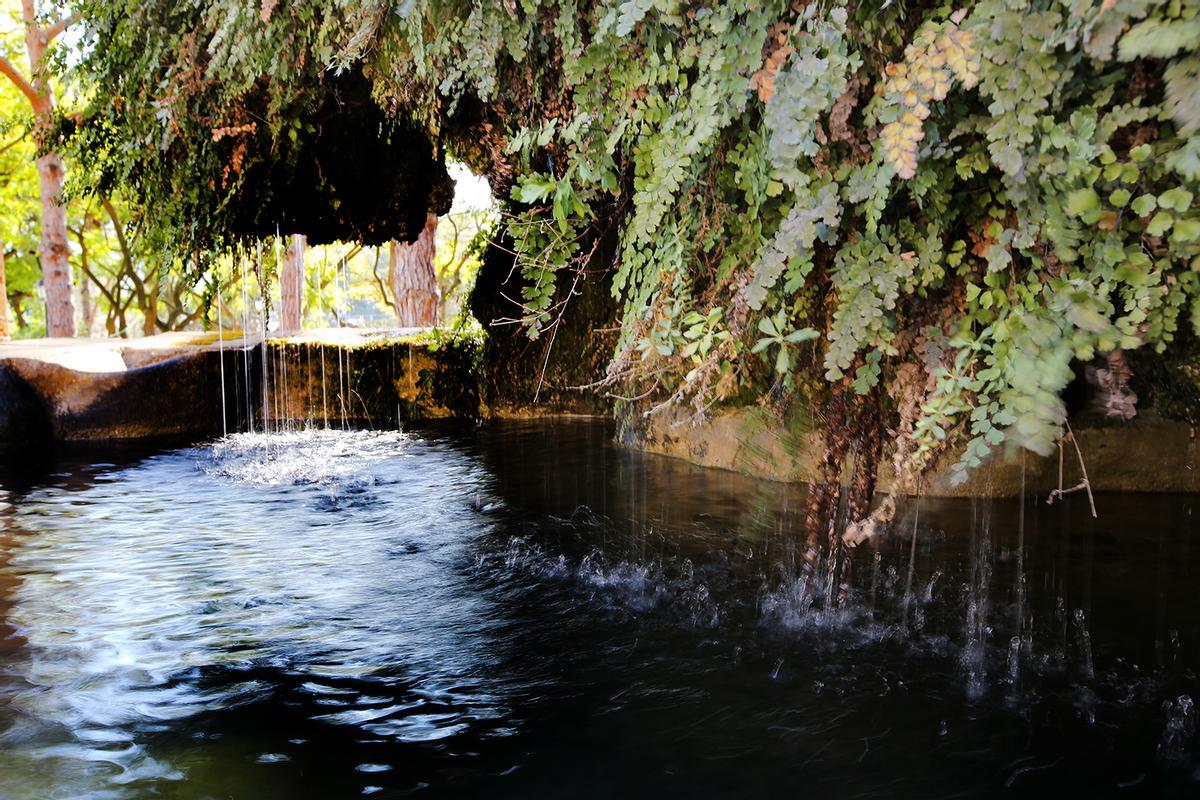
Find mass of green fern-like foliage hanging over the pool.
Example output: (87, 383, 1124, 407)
(65, 0, 1200, 491)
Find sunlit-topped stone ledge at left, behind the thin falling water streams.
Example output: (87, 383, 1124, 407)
(0, 332, 480, 449)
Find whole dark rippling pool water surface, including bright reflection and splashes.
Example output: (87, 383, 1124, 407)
(0, 421, 1200, 800)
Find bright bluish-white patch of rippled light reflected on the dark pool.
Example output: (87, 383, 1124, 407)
(0, 433, 520, 796)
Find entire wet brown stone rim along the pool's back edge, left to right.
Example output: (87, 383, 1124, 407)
(0, 326, 1196, 497)
